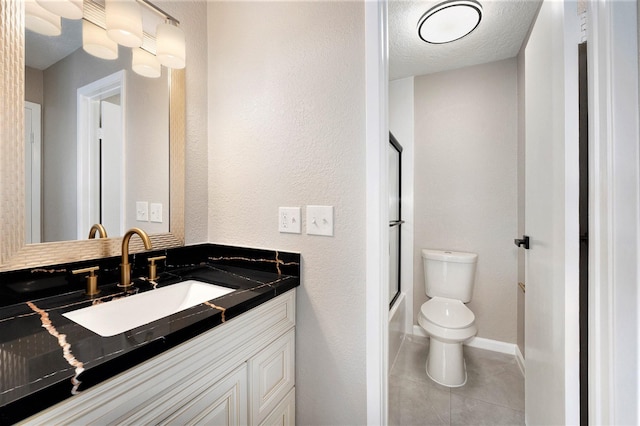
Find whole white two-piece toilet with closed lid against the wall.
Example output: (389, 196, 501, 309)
(418, 249, 478, 387)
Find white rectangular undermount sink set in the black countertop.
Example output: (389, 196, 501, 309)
(62, 280, 234, 337)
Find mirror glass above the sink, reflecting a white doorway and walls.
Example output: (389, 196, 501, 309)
(25, 18, 169, 244)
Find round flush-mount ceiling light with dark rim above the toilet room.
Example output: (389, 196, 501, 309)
(418, 0, 482, 44)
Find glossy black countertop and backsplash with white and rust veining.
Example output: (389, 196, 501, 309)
(0, 244, 300, 424)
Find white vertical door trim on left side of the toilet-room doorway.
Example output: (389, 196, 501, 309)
(364, 0, 389, 425)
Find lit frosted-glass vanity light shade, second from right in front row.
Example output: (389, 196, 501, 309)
(104, 0, 142, 47)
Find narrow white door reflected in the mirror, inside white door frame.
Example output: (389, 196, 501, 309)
(96, 101, 124, 236)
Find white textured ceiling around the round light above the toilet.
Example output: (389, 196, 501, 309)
(389, 0, 541, 80)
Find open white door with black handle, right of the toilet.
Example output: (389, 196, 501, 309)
(525, 0, 579, 426)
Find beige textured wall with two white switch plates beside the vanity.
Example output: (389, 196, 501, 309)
(208, 2, 366, 425)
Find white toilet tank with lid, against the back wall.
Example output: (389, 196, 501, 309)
(422, 249, 478, 303)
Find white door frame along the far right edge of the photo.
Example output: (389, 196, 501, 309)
(587, 0, 640, 424)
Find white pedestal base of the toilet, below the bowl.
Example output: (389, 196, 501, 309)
(426, 336, 467, 388)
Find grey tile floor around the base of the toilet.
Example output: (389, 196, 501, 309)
(389, 335, 524, 426)
